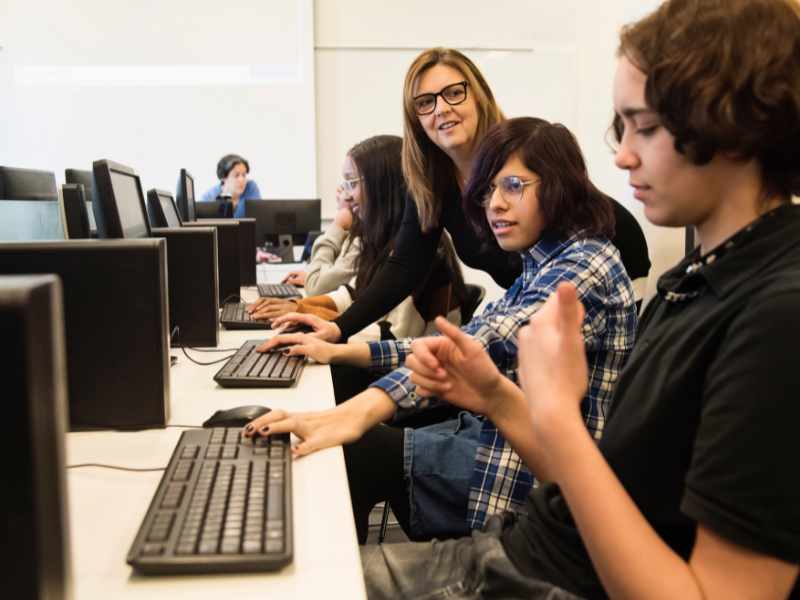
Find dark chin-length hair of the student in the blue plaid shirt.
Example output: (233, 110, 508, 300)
(464, 117, 614, 239)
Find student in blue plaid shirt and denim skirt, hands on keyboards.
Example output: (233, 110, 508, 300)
(245, 118, 636, 543)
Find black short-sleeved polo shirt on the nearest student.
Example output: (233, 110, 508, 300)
(503, 206, 800, 598)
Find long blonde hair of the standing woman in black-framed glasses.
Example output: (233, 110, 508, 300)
(403, 48, 504, 231)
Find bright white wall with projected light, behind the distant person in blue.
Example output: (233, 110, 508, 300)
(0, 0, 316, 197)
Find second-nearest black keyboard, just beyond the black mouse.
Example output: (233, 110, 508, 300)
(214, 340, 305, 387)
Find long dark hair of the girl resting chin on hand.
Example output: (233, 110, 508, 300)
(347, 135, 407, 292)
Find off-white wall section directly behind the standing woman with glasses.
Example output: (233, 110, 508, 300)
(315, 0, 683, 296)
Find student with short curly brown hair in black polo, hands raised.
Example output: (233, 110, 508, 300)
(364, 0, 800, 600)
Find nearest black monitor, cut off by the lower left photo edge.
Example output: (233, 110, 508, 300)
(0, 275, 72, 600)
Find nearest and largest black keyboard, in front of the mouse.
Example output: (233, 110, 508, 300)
(127, 428, 293, 574)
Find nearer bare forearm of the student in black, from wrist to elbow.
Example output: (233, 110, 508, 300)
(548, 418, 704, 600)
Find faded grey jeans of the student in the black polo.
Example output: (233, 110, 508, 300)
(361, 515, 579, 600)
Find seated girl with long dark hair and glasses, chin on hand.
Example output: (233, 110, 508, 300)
(249, 135, 465, 340)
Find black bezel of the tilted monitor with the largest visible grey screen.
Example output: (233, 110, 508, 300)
(92, 159, 151, 239)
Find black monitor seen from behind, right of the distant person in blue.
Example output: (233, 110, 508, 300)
(244, 198, 321, 246)
